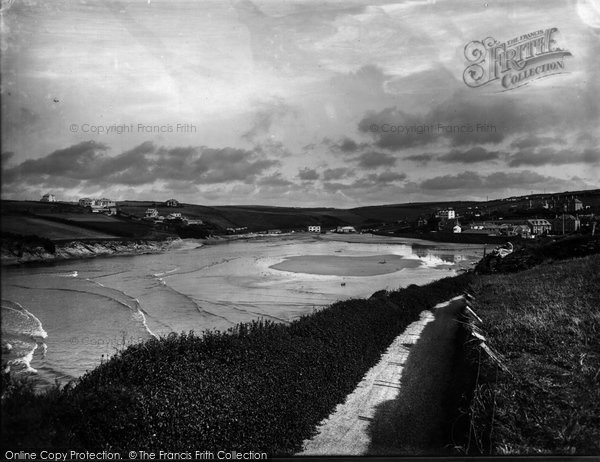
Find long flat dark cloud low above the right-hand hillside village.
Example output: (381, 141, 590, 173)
(420, 170, 572, 191)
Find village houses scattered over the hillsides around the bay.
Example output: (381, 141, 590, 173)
(35, 193, 600, 239)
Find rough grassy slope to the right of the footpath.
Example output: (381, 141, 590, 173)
(468, 255, 600, 455)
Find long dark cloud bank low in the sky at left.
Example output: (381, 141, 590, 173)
(3, 141, 279, 186)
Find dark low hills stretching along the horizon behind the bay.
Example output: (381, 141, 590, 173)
(0, 189, 600, 239)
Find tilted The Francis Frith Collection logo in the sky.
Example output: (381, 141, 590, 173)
(463, 27, 572, 91)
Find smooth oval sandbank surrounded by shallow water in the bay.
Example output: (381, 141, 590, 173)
(271, 254, 421, 277)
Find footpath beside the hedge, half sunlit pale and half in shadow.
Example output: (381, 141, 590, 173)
(298, 297, 464, 455)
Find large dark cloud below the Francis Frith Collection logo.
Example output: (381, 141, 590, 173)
(358, 92, 580, 151)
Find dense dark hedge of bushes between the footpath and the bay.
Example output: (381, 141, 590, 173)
(2, 274, 471, 455)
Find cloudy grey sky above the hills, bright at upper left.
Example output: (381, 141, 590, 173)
(1, 0, 600, 207)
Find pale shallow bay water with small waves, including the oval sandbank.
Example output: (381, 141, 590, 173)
(1, 236, 482, 387)
